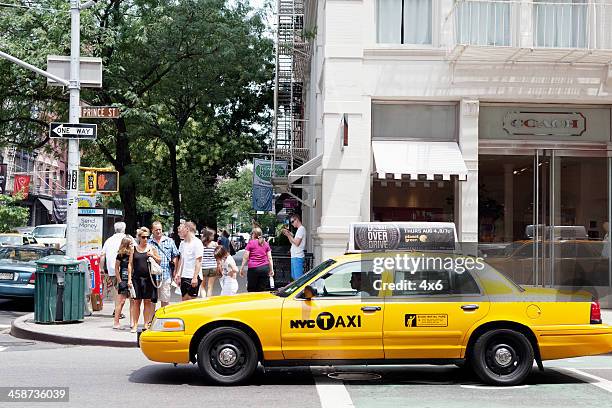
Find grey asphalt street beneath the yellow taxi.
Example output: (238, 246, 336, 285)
(0, 342, 612, 408)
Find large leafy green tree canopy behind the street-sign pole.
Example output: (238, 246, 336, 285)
(0, 0, 273, 236)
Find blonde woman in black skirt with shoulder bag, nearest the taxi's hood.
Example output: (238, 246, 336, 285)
(129, 227, 161, 333)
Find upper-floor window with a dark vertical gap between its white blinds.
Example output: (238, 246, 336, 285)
(376, 0, 433, 44)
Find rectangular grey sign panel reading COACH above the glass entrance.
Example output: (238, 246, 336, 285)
(479, 106, 610, 142)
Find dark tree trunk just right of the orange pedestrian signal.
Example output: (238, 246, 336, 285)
(115, 119, 137, 234)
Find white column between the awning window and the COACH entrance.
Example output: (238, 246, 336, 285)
(456, 99, 480, 242)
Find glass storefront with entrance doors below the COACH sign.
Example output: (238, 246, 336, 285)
(478, 150, 611, 290)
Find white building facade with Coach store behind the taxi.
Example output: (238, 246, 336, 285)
(289, 0, 612, 305)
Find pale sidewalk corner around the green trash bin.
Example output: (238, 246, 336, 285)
(11, 299, 612, 347)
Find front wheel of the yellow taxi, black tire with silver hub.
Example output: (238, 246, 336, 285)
(197, 327, 258, 385)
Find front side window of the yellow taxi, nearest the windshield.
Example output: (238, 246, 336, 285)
(310, 262, 380, 298)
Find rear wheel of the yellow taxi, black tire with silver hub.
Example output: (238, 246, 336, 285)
(470, 329, 533, 385)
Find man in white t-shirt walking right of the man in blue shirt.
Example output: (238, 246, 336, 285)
(174, 222, 204, 300)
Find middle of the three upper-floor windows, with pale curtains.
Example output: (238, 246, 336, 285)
(455, 0, 511, 46)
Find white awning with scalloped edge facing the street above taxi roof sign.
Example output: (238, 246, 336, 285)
(372, 140, 468, 180)
